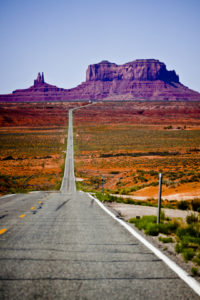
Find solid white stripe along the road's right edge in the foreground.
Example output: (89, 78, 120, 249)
(87, 193, 200, 296)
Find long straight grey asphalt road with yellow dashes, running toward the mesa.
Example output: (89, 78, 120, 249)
(0, 112, 199, 300)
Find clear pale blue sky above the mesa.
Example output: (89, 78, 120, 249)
(0, 0, 200, 94)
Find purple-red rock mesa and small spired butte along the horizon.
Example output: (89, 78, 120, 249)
(0, 59, 200, 102)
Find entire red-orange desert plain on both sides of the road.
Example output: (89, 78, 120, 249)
(0, 101, 200, 201)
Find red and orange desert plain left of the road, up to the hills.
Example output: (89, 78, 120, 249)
(0, 103, 78, 194)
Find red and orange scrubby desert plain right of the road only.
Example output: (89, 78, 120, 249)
(74, 102, 200, 200)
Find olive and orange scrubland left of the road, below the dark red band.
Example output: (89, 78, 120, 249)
(0, 127, 66, 194)
